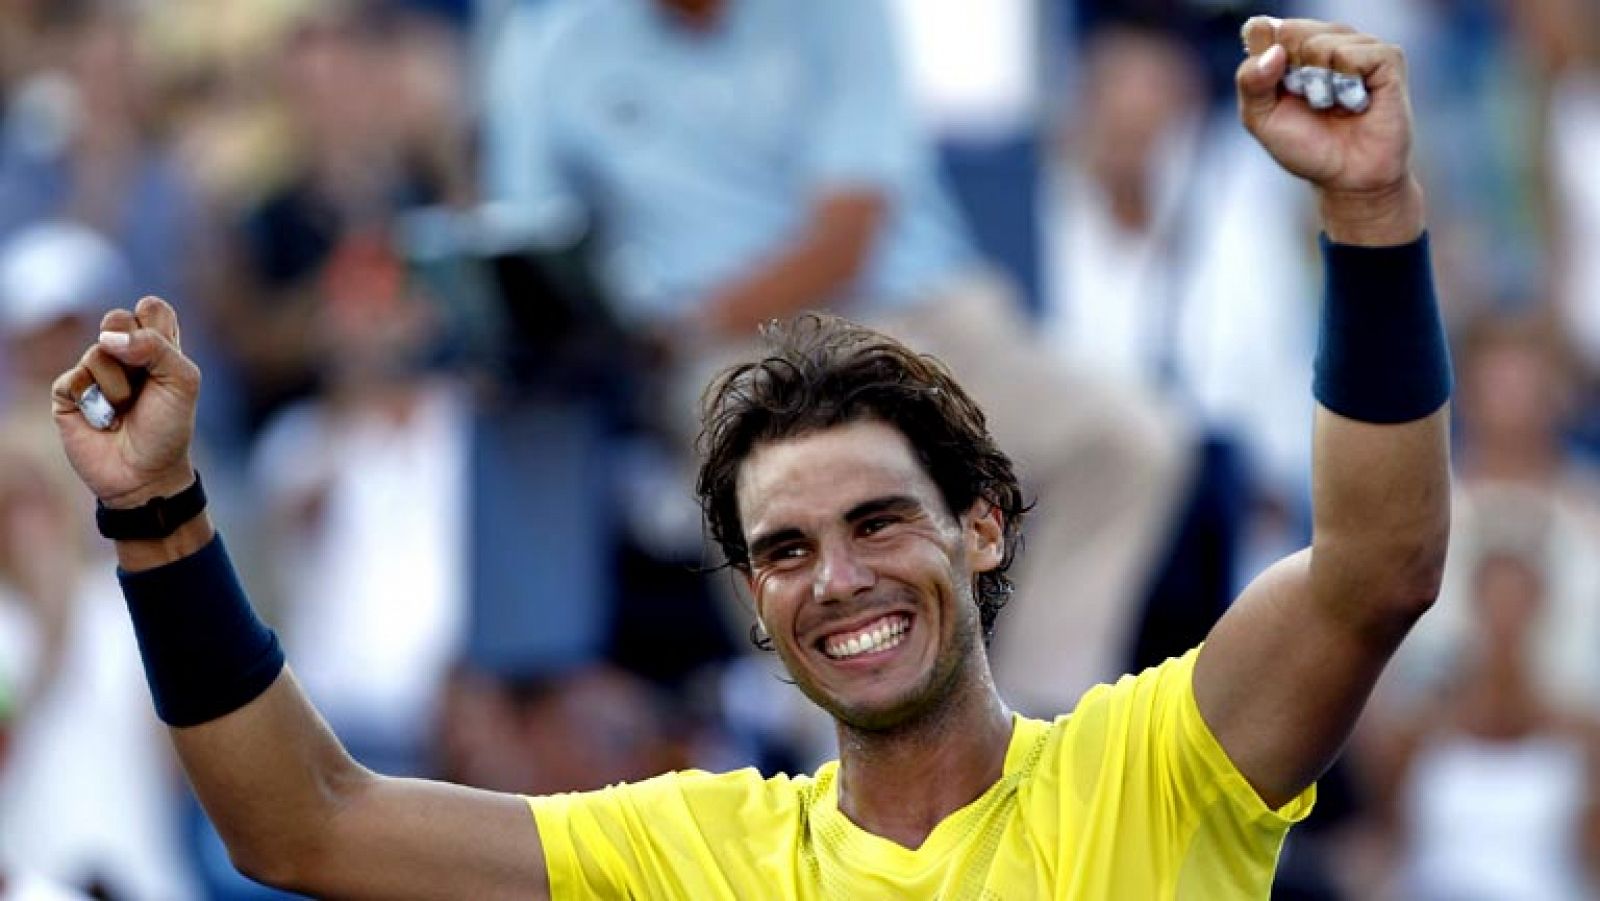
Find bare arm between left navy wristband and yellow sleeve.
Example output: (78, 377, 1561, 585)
(171, 656, 549, 899)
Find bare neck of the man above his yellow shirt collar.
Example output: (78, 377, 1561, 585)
(838, 674, 1011, 848)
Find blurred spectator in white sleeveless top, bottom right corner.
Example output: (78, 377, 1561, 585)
(1358, 552, 1600, 901)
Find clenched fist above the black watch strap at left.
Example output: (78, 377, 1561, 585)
(51, 298, 200, 507)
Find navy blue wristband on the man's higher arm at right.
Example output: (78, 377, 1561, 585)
(1314, 234, 1454, 424)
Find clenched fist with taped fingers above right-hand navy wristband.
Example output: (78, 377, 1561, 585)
(1235, 16, 1424, 245)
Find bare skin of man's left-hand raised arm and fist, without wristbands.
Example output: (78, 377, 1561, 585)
(51, 298, 549, 898)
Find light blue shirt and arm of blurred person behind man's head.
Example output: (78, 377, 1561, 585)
(486, 0, 979, 333)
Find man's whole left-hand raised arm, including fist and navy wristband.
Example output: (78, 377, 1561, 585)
(51, 298, 549, 898)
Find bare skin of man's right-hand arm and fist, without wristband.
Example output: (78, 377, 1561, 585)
(1194, 19, 1450, 807)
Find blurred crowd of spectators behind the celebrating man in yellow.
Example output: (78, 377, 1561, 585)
(0, 0, 1600, 901)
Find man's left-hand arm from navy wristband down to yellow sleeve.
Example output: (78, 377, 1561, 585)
(132, 544, 542, 898)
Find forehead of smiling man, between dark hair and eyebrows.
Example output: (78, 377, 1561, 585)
(738, 421, 938, 536)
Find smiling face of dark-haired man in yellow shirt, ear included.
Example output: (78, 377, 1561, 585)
(738, 421, 1003, 731)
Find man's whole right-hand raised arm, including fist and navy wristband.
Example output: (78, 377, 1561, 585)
(1194, 18, 1450, 805)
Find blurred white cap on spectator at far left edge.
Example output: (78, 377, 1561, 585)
(0, 221, 130, 334)
